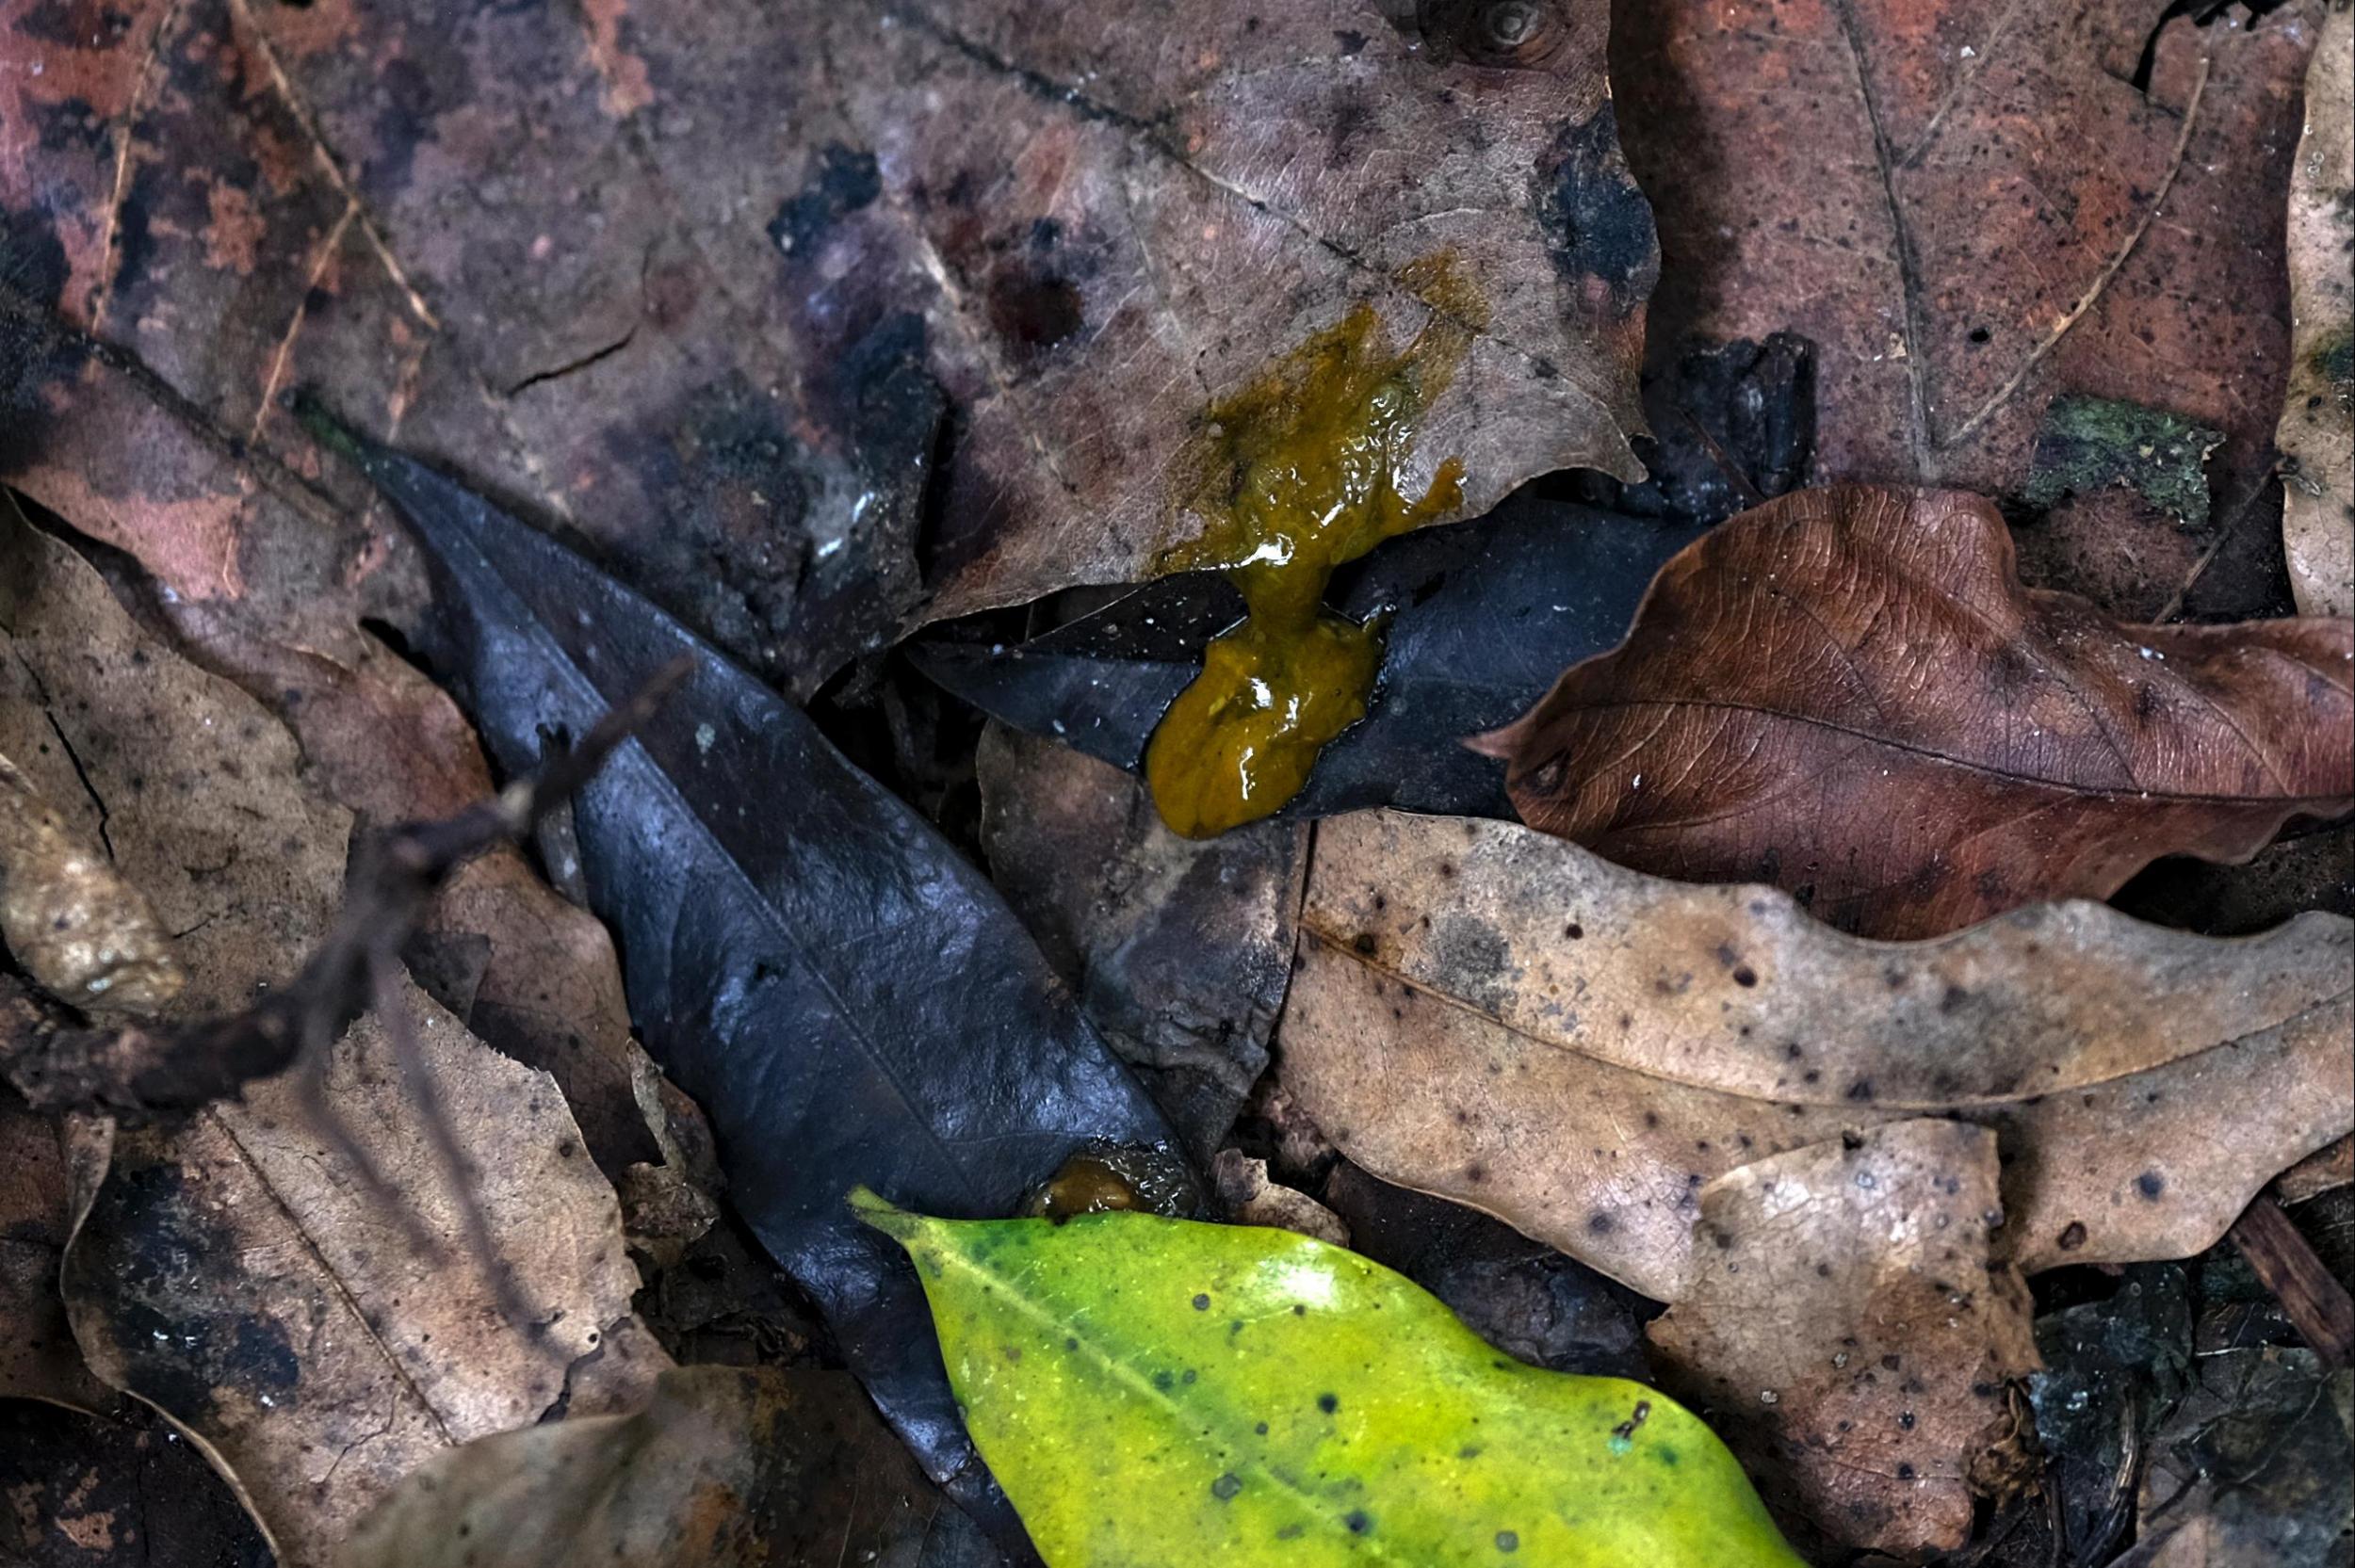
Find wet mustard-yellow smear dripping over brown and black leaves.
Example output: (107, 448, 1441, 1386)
(1145, 254, 1486, 838)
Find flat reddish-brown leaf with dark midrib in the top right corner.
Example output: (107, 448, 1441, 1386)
(1611, 0, 2320, 567)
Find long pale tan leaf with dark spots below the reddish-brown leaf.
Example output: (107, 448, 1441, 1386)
(1276, 813, 2355, 1302)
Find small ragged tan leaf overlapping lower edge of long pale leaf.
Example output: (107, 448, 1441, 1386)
(1648, 1121, 2038, 1554)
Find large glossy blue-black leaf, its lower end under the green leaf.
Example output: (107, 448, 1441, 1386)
(332, 421, 1168, 1524)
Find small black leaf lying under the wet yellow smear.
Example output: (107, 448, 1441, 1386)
(909, 493, 1700, 819)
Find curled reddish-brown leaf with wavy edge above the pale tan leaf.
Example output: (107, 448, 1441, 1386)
(1482, 485, 2355, 937)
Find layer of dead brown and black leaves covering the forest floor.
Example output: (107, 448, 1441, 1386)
(0, 0, 2355, 1568)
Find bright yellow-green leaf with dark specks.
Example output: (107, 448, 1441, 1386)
(851, 1189, 1804, 1568)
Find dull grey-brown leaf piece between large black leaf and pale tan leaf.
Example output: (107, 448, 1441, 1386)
(975, 725, 1309, 1166)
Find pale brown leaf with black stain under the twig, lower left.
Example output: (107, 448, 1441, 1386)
(64, 989, 662, 1568)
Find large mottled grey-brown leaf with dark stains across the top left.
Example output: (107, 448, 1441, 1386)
(0, 0, 1656, 692)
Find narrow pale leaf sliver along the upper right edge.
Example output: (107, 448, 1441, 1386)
(2275, 0, 2355, 615)
